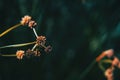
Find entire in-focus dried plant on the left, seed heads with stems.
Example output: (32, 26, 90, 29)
(0, 15, 52, 59)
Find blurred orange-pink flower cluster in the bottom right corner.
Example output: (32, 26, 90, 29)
(96, 49, 120, 80)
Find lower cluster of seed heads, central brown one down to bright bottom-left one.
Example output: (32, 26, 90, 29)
(16, 36, 52, 59)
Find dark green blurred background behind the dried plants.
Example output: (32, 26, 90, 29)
(0, 0, 120, 80)
